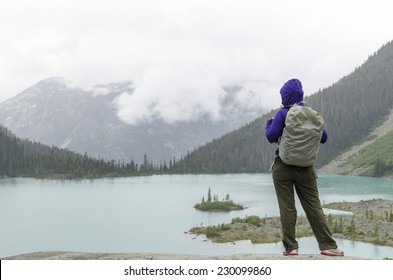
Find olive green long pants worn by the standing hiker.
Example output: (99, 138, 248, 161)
(272, 160, 337, 251)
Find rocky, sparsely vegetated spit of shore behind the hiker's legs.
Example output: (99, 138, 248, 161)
(189, 199, 393, 246)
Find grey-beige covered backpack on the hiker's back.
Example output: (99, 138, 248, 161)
(279, 104, 324, 167)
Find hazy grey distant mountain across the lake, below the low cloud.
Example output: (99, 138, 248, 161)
(0, 77, 261, 163)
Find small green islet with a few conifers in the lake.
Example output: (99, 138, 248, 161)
(194, 188, 244, 212)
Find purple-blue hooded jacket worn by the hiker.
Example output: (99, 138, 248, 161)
(265, 79, 328, 147)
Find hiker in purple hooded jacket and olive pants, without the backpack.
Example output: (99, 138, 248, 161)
(266, 79, 344, 256)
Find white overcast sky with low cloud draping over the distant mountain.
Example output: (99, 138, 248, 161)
(0, 0, 393, 123)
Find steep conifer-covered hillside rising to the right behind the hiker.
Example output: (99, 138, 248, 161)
(171, 42, 393, 173)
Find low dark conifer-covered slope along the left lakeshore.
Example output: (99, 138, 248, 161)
(0, 126, 158, 179)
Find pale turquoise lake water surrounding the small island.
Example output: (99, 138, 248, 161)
(0, 174, 393, 259)
